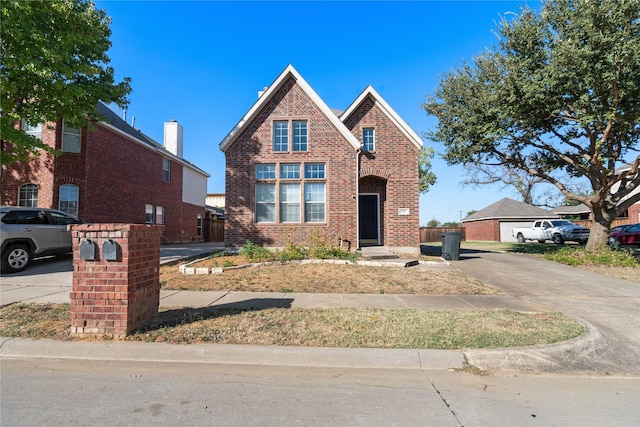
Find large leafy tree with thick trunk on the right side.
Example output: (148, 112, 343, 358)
(423, 0, 640, 248)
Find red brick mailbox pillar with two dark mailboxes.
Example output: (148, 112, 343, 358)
(71, 224, 164, 337)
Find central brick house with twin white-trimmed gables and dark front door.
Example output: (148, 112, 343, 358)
(220, 65, 422, 251)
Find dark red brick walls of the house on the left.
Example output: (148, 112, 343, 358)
(1, 122, 205, 242)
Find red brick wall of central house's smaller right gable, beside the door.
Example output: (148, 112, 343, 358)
(345, 98, 420, 247)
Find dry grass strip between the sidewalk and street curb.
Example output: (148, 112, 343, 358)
(0, 304, 583, 349)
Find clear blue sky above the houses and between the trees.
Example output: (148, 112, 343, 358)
(96, 0, 540, 225)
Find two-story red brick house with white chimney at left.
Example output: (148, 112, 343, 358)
(0, 104, 209, 242)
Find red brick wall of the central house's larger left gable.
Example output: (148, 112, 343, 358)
(225, 79, 356, 247)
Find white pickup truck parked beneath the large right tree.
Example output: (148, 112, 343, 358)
(511, 219, 589, 245)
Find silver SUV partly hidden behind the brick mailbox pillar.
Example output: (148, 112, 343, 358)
(0, 206, 81, 273)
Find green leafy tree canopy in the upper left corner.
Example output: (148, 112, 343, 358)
(0, 0, 131, 164)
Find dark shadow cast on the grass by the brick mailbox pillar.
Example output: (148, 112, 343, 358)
(135, 298, 293, 333)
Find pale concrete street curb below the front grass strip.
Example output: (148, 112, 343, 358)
(0, 337, 464, 370)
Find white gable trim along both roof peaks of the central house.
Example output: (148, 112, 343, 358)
(220, 64, 422, 151)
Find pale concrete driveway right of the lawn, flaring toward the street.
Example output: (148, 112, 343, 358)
(452, 251, 640, 375)
